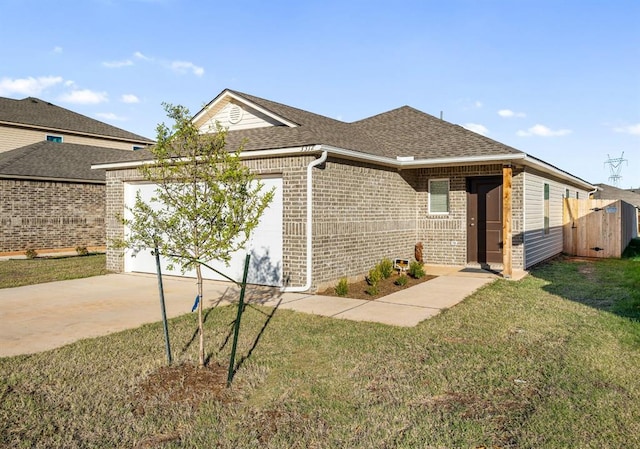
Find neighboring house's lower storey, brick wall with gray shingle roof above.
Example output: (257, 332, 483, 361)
(0, 141, 138, 253)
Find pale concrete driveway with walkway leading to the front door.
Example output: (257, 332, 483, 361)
(0, 266, 524, 357)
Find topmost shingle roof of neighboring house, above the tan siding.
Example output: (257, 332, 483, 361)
(0, 97, 153, 143)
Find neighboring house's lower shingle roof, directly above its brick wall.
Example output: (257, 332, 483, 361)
(0, 141, 133, 181)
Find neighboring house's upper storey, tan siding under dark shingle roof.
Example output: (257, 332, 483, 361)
(0, 97, 153, 153)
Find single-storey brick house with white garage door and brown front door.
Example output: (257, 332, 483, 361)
(95, 90, 594, 291)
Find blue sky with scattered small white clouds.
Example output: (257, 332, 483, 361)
(0, 0, 640, 188)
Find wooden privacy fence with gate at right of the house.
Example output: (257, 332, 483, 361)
(563, 198, 638, 258)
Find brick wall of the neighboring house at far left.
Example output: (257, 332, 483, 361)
(0, 179, 106, 252)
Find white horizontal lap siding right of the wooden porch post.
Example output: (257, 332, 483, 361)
(524, 172, 588, 269)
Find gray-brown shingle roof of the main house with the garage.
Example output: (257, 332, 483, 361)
(101, 90, 524, 162)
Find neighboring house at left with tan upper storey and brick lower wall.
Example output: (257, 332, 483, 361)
(0, 97, 153, 255)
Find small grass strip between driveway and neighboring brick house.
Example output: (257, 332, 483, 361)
(0, 254, 108, 288)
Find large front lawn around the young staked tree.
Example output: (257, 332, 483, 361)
(0, 260, 640, 449)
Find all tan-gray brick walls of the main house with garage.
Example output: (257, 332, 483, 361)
(106, 156, 523, 290)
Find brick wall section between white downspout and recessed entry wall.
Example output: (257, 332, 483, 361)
(312, 159, 417, 287)
